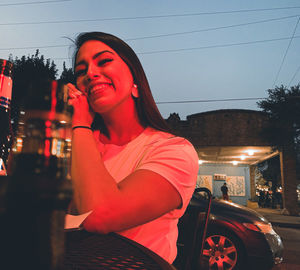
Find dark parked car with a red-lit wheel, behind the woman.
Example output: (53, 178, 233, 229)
(174, 192, 283, 270)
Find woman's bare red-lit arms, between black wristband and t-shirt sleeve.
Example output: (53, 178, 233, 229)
(72, 128, 181, 233)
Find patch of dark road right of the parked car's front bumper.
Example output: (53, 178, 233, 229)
(272, 226, 300, 270)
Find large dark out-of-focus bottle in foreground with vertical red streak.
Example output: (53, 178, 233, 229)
(0, 80, 72, 270)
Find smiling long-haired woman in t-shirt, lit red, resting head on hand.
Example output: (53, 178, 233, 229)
(68, 32, 198, 263)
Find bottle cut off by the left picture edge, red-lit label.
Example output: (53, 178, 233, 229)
(0, 59, 13, 175)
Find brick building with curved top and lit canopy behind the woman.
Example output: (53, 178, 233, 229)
(167, 109, 297, 214)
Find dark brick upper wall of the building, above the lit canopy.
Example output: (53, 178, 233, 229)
(167, 110, 270, 148)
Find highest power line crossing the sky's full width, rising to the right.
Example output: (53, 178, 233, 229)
(0, 6, 300, 26)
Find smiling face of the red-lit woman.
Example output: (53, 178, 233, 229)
(75, 40, 134, 114)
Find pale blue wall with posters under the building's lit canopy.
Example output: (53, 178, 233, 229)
(198, 164, 250, 206)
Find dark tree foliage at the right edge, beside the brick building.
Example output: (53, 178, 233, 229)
(257, 85, 300, 178)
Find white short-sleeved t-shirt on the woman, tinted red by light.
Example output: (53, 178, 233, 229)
(94, 128, 198, 263)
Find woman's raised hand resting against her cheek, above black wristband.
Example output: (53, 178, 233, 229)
(67, 83, 95, 126)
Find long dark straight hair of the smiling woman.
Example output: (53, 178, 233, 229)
(73, 32, 170, 136)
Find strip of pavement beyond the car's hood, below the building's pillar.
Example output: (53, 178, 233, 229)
(251, 207, 300, 229)
